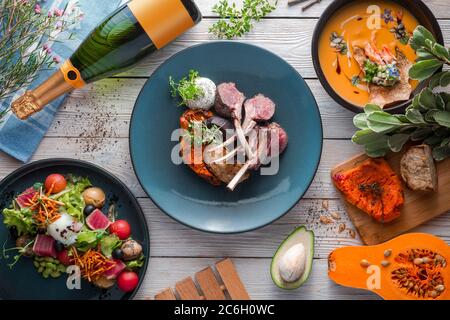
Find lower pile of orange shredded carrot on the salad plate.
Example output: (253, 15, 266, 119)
(72, 248, 114, 282)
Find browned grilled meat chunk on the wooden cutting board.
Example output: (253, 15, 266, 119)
(400, 145, 438, 191)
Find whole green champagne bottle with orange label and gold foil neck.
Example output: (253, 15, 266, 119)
(11, 0, 202, 120)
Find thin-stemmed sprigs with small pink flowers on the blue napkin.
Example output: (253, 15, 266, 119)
(0, 0, 83, 121)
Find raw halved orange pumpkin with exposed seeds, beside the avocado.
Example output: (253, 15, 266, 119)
(328, 233, 450, 300)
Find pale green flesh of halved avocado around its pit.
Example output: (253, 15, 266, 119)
(270, 226, 314, 290)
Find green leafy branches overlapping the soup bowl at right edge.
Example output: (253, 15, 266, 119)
(352, 26, 450, 161)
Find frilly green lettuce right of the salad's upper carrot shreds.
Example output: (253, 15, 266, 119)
(55, 177, 92, 221)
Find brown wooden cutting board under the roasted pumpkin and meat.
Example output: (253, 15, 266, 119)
(331, 153, 450, 245)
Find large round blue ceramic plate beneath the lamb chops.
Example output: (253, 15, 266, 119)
(130, 41, 322, 233)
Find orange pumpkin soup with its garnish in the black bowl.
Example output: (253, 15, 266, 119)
(319, 1, 419, 108)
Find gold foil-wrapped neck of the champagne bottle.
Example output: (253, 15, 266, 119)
(11, 60, 84, 120)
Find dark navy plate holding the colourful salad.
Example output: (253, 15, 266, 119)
(0, 159, 150, 300)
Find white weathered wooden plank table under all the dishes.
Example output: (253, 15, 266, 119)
(0, 0, 450, 299)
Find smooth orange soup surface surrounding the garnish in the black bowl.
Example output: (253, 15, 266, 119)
(319, 1, 419, 107)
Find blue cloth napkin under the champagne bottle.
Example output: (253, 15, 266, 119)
(0, 0, 122, 162)
